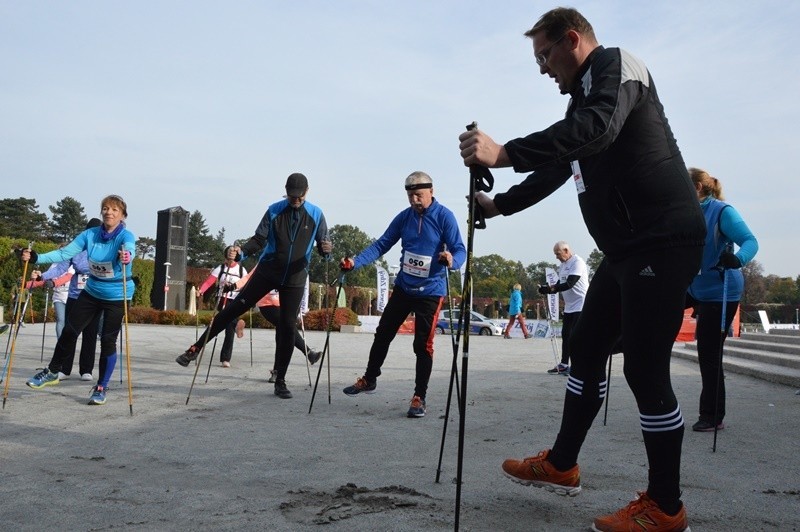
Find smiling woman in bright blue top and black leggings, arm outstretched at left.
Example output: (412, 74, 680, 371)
(22, 195, 136, 405)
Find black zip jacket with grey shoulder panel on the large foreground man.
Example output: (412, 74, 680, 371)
(494, 46, 706, 258)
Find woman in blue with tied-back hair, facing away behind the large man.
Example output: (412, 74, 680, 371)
(686, 168, 758, 432)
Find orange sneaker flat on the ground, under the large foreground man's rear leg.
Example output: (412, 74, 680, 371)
(592, 492, 691, 532)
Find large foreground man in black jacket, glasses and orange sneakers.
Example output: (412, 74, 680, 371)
(459, 8, 705, 530)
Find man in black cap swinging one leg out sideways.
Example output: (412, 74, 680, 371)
(175, 174, 332, 399)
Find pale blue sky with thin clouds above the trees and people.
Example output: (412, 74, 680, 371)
(0, 0, 800, 277)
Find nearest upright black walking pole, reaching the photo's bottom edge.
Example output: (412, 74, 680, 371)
(455, 122, 494, 530)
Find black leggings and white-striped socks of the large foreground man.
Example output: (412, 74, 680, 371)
(551, 246, 702, 507)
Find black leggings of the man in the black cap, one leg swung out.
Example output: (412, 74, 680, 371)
(194, 264, 305, 380)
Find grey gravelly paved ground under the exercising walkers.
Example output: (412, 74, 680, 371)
(0, 325, 800, 532)
